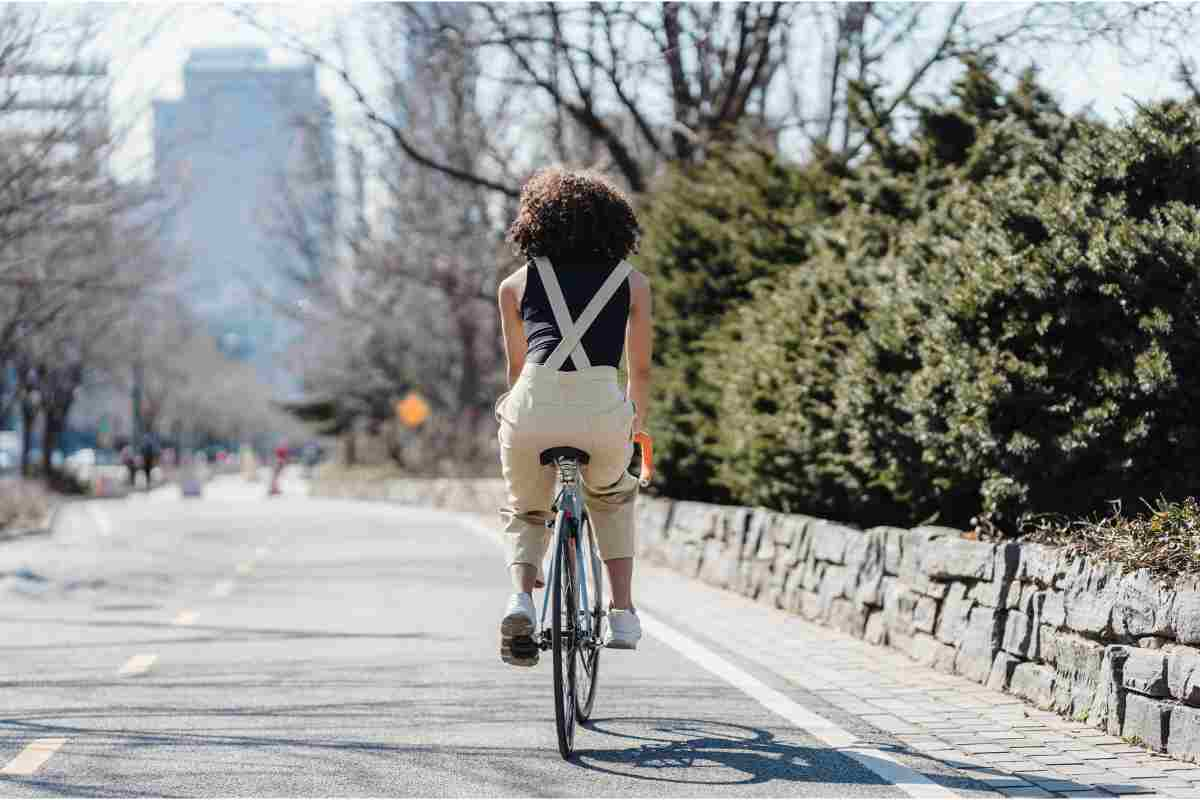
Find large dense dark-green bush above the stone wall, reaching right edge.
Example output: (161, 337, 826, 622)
(647, 59, 1200, 529)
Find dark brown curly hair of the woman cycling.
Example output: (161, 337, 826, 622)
(508, 167, 641, 264)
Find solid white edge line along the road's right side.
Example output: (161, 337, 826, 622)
(456, 515, 959, 798)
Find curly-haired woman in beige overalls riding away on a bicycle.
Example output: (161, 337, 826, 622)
(496, 167, 652, 667)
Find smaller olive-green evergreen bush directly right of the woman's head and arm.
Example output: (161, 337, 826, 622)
(637, 151, 833, 500)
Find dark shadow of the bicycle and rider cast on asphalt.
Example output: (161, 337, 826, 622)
(575, 717, 890, 787)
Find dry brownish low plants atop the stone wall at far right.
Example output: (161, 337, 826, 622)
(1022, 498, 1200, 577)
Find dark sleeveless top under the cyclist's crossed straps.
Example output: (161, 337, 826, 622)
(521, 261, 629, 372)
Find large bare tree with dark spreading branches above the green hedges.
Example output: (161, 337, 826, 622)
(238, 2, 1195, 198)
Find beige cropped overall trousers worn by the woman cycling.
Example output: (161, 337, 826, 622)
(496, 363, 637, 566)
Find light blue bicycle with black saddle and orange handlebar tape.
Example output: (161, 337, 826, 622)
(534, 433, 654, 759)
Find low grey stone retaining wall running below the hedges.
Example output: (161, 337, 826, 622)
(316, 480, 1200, 760)
